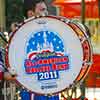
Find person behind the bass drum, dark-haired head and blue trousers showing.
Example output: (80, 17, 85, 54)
(21, 0, 59, 100)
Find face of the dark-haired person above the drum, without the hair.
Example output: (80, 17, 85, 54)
(35, 2, 48, 16)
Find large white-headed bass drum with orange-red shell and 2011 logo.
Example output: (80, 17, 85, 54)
(6, 16, 92, 95)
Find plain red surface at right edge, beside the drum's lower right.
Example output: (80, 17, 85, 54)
(85, 54, 100, 88)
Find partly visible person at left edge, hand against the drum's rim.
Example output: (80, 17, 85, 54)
(0, 26, 15, 100)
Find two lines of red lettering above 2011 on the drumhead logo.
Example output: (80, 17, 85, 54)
(25, 56, 69, 73)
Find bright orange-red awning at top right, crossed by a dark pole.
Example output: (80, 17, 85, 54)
(53, 0, 99, 18)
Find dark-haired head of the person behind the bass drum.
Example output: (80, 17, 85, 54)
(24, 0, 48, 18)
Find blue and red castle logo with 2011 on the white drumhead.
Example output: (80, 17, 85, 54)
(24, 31, 69, 89)
